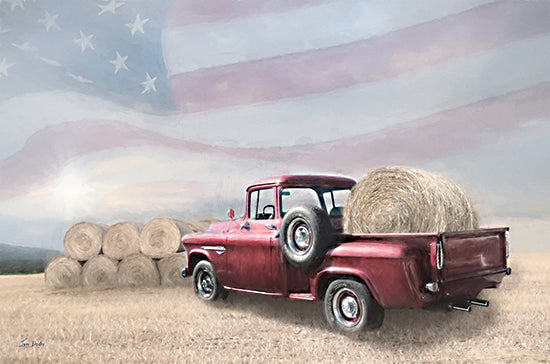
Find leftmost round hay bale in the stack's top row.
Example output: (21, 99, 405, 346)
(63, 222, 106, 261)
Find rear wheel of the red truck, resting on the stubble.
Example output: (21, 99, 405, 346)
(325, 279, 384, 333)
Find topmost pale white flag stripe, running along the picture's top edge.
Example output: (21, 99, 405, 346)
(162, 0, 491, 76)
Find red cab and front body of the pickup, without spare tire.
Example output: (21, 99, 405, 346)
(182, 176, 355, 295)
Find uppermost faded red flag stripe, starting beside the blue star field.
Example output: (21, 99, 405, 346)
(169, 1, 550, 113)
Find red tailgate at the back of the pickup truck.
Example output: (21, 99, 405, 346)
(440, 228, 509, 282)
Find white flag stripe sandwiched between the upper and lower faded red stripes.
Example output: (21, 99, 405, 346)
(173, 35, 550, 147)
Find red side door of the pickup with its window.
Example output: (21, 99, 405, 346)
(226, 187, 278, 292)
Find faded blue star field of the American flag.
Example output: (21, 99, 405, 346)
(0, 0, 172, 112)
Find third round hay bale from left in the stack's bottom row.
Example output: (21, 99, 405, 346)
(117, 253, 160, 287)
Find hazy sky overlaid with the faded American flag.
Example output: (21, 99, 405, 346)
(0, 0, 550, 253)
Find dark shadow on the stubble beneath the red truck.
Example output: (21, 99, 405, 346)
(215, 292, 499, 347)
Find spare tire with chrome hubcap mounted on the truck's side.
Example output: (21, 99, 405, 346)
(280, 205, 335, 268)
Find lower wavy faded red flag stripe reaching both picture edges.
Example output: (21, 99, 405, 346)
(0, 82, 550, 201)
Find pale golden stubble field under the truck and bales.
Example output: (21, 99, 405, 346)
(0, 254, 550, 363)
